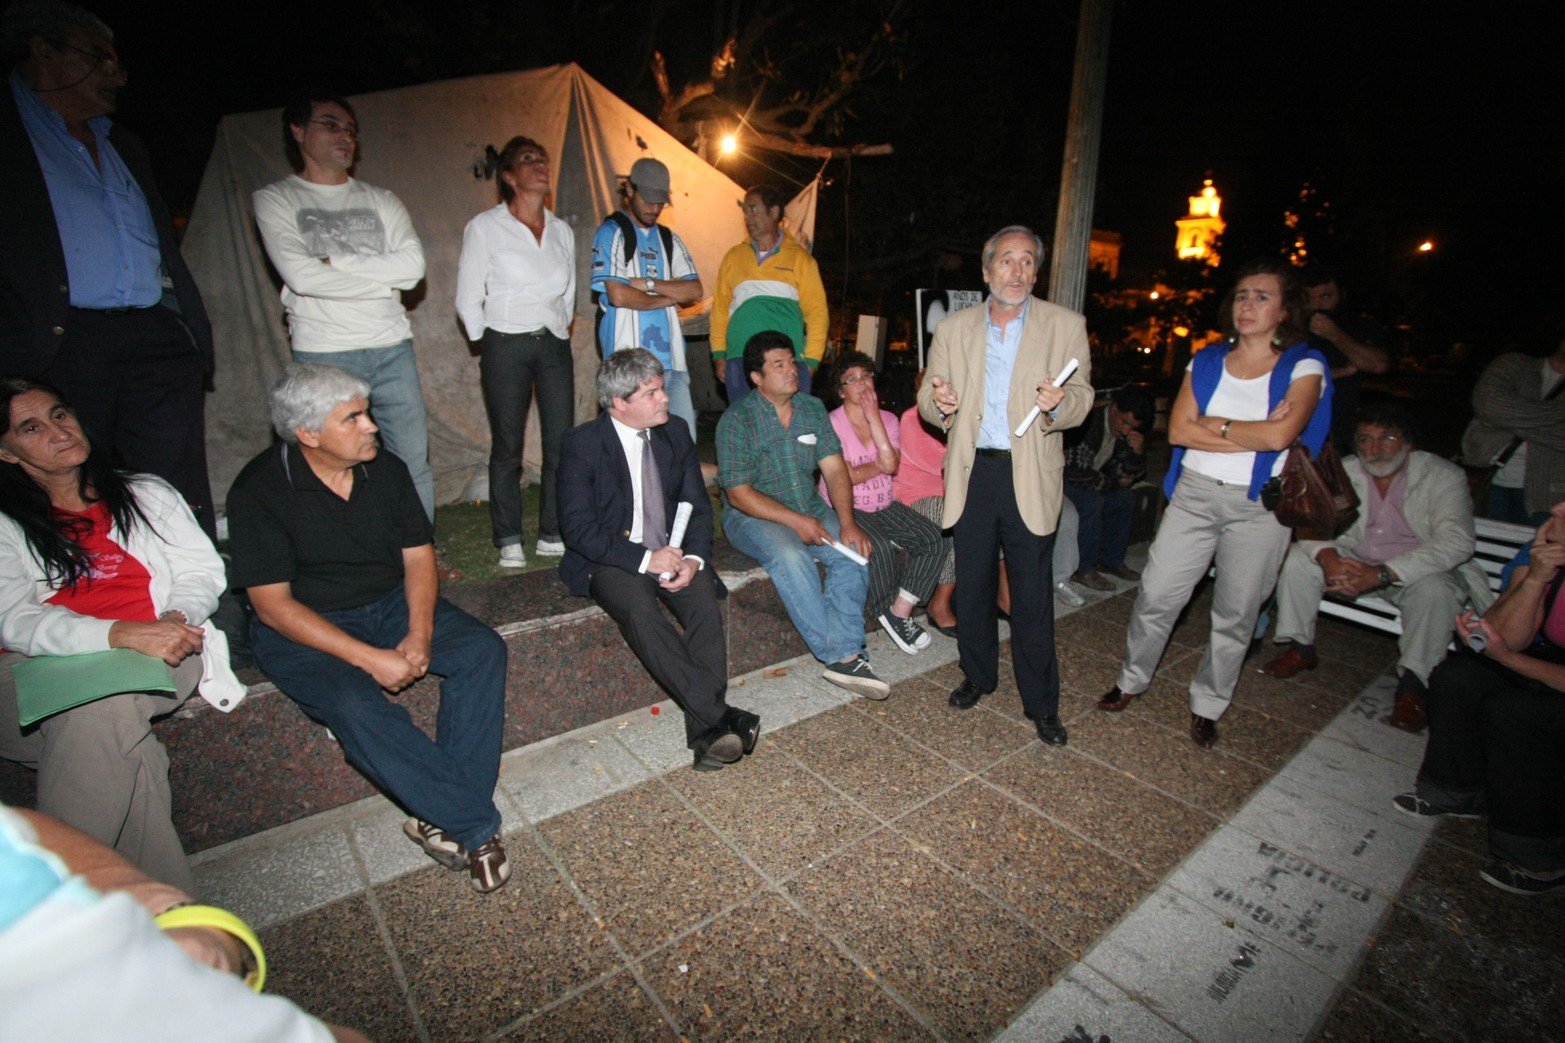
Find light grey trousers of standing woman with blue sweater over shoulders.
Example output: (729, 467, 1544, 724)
(1119, 470, 1293, 720)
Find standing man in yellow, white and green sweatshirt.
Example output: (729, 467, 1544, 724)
(712, 185, 829, 406)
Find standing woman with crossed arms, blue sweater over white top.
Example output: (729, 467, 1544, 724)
(1097, 260, 1332, 747)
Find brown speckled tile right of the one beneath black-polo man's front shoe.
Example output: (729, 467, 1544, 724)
(540, 771, 761, 954)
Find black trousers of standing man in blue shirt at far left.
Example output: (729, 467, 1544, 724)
(38, 307, 218, 537)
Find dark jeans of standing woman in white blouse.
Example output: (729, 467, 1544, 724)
(479, 329, 576, 547)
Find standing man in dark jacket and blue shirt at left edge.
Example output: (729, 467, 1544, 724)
(0, 0, 216, 536)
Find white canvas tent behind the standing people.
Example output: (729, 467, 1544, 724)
(183, 64, 814, 504)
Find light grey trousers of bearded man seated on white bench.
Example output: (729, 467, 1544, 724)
(1277, 547, 1468, 684)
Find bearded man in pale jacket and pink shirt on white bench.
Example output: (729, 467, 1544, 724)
(1261, 398, 1493, 731)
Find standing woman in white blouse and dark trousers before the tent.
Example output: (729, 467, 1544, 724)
(457, 136, 576, 568)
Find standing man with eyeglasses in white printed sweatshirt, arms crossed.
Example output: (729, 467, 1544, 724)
(254, 94, 454, 578)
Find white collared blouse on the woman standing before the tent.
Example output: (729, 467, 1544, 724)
(457, 204, 576, 340)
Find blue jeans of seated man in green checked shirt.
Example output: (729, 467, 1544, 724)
(723, 511, 870, 662)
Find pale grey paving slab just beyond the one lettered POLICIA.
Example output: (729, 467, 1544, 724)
(1232, 775, 1429, 897)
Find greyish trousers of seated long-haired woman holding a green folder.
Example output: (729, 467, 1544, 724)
(0, 651, 200, 894)
